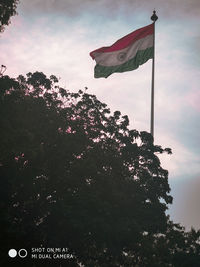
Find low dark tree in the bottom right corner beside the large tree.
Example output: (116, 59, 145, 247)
(126, 218, 200, 267)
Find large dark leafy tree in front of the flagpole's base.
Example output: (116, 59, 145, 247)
(0, 72, 180, 267)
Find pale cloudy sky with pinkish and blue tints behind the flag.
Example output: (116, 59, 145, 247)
(0, 0, 200, 230)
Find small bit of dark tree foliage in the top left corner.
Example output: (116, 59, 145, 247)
(0, 0, 19, 32)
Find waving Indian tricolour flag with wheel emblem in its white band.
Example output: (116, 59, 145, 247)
(90, 23, 154, 78)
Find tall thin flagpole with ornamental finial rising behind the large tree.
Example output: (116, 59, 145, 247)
(150, 10, 158, 136)
